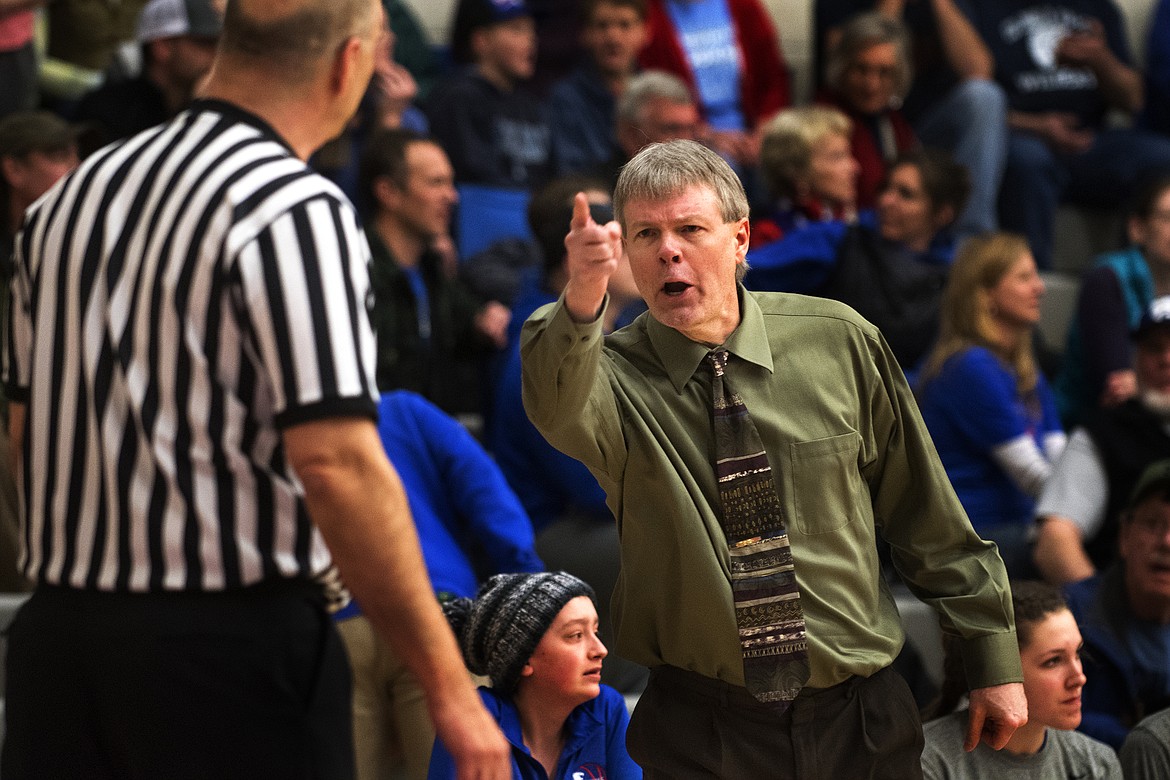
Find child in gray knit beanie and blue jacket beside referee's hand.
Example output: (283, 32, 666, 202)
(428, 572, 642, 780)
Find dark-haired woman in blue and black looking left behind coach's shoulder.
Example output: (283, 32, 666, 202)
(744, 149, 968, 368)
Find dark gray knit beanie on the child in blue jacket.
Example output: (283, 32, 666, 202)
(443, 572, 597, 695)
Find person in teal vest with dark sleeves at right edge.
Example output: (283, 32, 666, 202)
(1057, 175, 1170, 426)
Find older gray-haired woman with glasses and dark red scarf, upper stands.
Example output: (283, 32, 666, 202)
(821, 12, 917, 208)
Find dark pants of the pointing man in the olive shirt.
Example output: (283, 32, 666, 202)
(626, 667, 922, 780)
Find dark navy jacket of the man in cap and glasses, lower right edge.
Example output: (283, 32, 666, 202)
(1065, 562, 1170, 750)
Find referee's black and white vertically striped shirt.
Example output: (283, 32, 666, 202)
(5, 101, 377, 592)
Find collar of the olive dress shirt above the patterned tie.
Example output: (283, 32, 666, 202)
(646, 284, 773, 393)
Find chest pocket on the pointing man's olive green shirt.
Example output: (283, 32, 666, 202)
(789, 432, 863, 536)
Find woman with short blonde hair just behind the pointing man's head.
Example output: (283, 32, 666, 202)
(751, 105, 859, 247)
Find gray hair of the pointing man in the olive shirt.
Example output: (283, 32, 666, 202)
(613, 140, 748, 227)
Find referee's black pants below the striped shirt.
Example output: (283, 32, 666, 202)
(0, 582, 353, 780)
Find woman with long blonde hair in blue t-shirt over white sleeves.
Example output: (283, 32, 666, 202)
(918, 233, 1065, 577)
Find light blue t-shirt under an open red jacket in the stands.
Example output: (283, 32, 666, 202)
(666, 0, 748, 130)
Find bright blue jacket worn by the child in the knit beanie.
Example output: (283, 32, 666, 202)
(427, 685, 642, 780)
